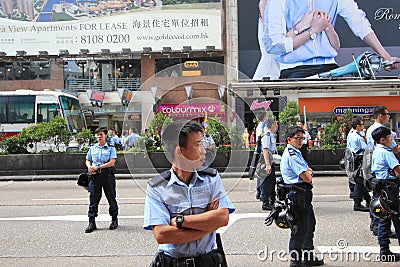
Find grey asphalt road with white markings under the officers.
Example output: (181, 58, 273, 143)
(0, 176, 400, 267)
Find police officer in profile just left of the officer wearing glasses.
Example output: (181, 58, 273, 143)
(260, 118, 278, 210)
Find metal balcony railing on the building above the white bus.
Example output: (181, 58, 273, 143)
(65, 78, 141, 92)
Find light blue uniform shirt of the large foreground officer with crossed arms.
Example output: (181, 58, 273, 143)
(143, 169, 235, 258)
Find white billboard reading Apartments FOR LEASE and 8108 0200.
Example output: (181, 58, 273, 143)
(0, 0, 222, 56)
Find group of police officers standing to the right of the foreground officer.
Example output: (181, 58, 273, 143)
(255, 106, 400, 266)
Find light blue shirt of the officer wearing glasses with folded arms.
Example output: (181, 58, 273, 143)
(280, 144, 308, 184)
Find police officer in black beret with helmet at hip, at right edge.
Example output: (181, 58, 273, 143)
(371, 127, 400, 261)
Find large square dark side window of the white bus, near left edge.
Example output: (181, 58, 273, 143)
(7, 95, 35, 123)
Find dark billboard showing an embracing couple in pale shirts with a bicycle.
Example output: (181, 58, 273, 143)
(238, 0, 400, 80)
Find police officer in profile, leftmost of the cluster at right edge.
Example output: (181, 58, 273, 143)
(347, 116, 371, 212)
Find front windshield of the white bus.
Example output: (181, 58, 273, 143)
(60, 96, 85, 133)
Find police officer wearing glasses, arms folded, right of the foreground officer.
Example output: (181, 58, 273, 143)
(280, 126, 324, 267)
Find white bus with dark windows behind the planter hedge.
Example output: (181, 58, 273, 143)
(0, 89, 86, 137)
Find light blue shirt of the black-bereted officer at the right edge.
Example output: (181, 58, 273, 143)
(371, 144, 400, 180)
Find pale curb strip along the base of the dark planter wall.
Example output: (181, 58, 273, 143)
(0, 170, 346, 181)
